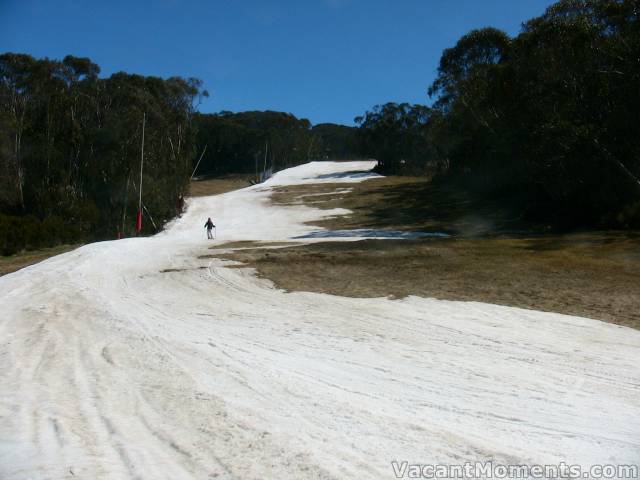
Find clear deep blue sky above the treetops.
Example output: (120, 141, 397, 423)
(0, 0, 553, 124)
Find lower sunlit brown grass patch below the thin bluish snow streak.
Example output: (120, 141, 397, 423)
(222, 233, 640, 328)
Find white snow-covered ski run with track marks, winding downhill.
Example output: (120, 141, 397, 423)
(0, 162, 640, 480)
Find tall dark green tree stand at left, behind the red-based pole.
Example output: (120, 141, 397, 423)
(0, 53, 206, 251)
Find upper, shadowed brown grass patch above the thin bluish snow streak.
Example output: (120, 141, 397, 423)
(271, 176, 548, 237)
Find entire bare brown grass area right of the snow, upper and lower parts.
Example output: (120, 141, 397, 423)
(220, 177, 640, 328)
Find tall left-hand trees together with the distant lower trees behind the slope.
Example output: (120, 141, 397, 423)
(0, 53, 356, 255)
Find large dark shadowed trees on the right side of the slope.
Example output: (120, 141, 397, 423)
(356, 0, 640, 228)
